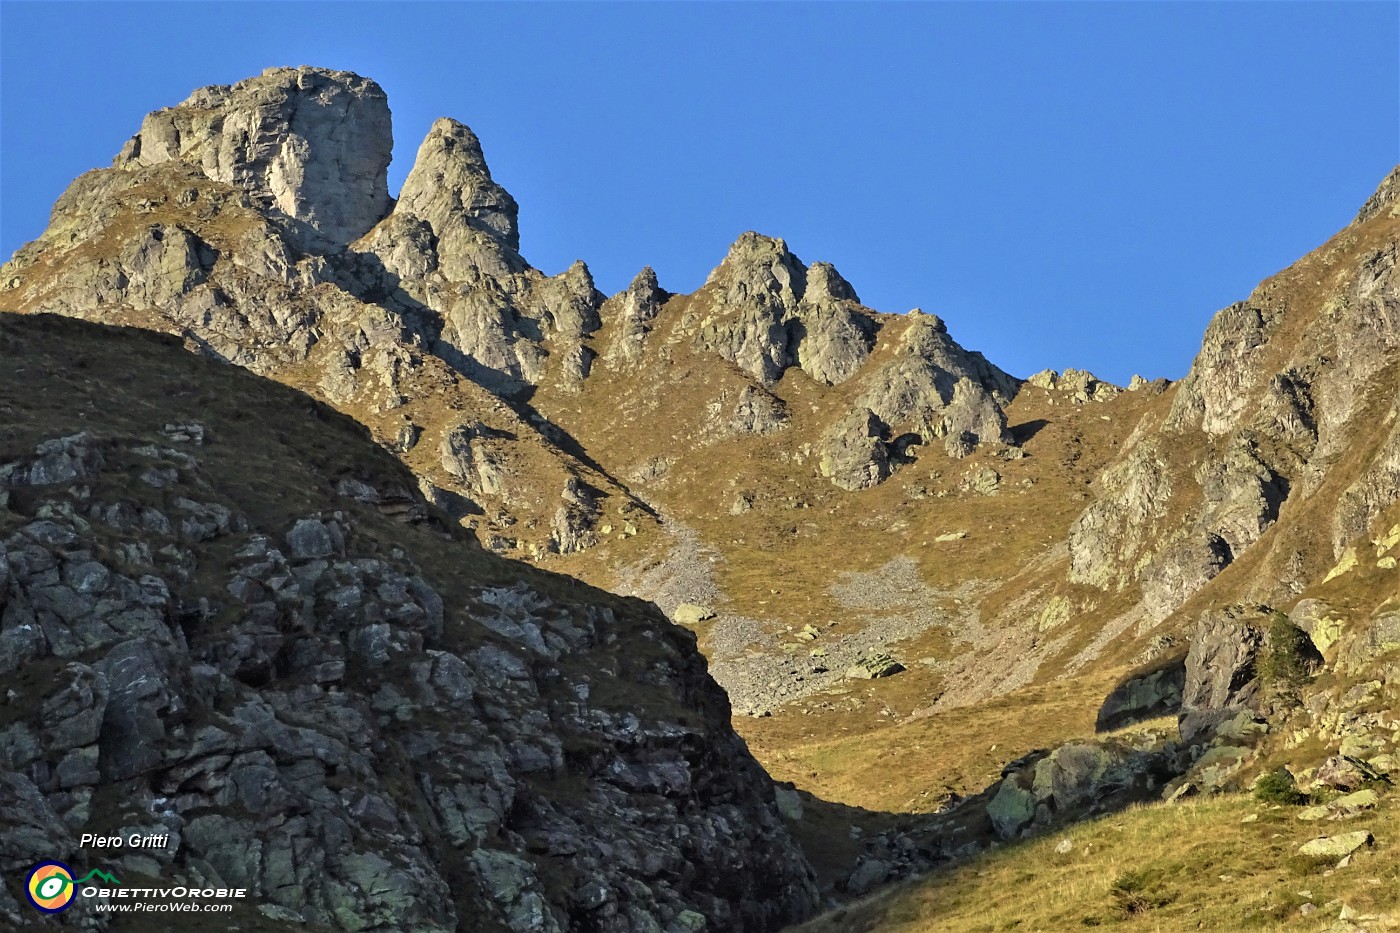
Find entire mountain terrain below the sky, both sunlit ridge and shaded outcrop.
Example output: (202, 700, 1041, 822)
(8, 67, 1400, 933)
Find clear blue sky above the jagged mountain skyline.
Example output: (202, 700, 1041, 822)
(0, 0, 1400, 381)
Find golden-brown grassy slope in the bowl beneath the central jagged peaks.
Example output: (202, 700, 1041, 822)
(536, 297, 1162, 745)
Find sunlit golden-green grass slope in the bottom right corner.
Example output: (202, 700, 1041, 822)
(792, 794, 1400, 933)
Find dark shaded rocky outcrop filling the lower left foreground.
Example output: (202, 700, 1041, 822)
(0, 315, 816, 933)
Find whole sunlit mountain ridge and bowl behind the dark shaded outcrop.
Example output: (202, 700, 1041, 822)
(8, 69, 1400, 929)
